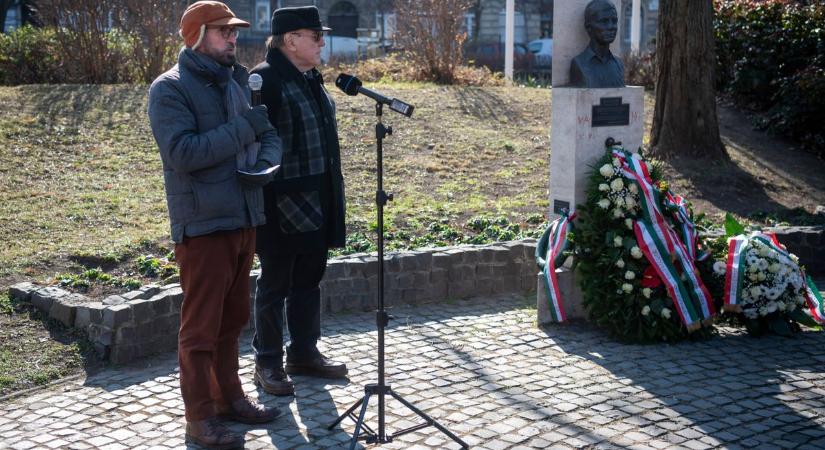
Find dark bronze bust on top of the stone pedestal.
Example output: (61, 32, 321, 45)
(570, 0, 625, 88)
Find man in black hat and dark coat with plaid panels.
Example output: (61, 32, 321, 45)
(246, 6, 347, 395)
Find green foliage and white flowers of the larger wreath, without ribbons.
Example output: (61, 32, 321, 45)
(575, 150, 724, 343)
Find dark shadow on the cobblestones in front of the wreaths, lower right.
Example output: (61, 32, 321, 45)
(543, 324, 825, 448)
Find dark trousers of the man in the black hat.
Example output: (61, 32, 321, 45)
(252, 249, 327, 368)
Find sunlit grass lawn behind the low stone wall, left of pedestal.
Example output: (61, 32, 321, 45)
(0, 85, 550, 284)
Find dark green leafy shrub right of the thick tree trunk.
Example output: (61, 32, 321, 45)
(714, 0, 825, 155)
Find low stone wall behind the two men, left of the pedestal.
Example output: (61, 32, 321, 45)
(9, 239, 536, 363)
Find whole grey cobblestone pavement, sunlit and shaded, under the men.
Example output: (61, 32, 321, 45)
(0, 298, 825, 450)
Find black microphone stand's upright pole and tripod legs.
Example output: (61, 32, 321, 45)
(327, 102, 470, 450)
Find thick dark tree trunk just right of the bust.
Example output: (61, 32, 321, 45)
(650, 0, 727, 159)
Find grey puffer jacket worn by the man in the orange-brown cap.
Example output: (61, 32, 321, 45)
(149, 49, 281, 243)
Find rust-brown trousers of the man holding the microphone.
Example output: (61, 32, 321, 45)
(175, 228, 255, 422)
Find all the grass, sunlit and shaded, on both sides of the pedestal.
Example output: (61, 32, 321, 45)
(0, 84, 825, 396)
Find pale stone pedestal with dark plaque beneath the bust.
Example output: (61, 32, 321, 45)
(537, 86, 644, 324)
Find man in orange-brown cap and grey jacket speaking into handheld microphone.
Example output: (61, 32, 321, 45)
(149, 1, 282, 449)
